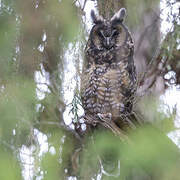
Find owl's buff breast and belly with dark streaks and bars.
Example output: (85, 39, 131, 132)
(81, 62, 135, 118)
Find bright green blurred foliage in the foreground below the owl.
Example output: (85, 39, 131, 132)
(82, 126, 180, 180)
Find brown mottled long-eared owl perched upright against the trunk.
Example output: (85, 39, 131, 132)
(81, 8, 137, 129)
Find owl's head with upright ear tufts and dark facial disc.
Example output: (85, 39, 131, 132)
(90, 8, 128, 50)
